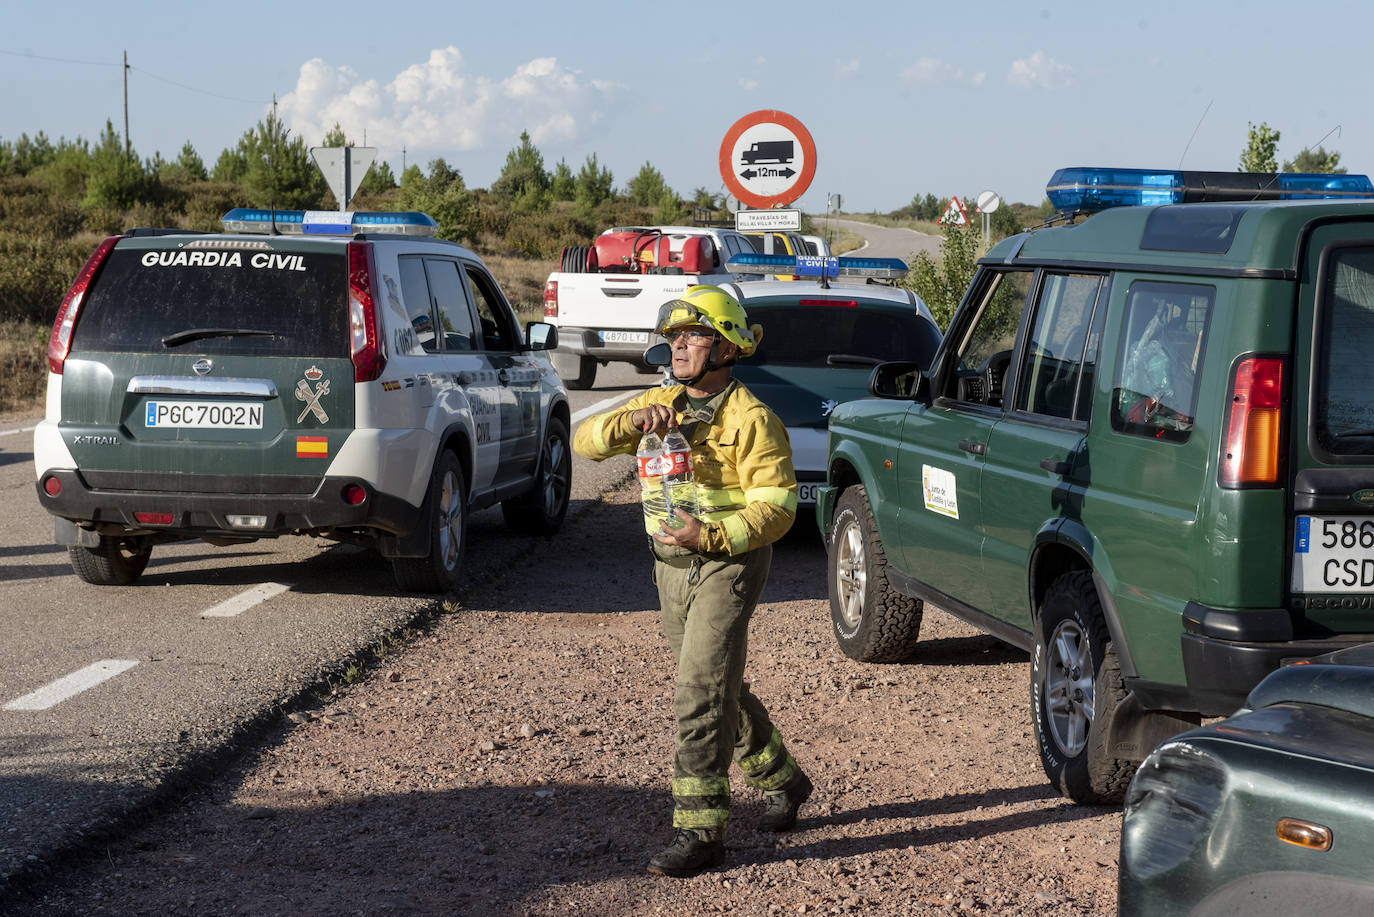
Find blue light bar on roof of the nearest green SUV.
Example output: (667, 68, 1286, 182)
(1044, 166, 1374, 213)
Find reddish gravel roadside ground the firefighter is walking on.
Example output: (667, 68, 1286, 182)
(10, 491, 1121, 917)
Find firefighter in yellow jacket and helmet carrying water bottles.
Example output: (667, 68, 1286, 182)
(573, 286, 812, 877)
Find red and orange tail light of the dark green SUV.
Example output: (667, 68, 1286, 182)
(1220, 356, 1283, 487)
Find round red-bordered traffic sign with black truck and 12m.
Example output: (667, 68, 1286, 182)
(720, 109, 816, 208)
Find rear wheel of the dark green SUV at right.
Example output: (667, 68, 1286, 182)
(1031, 571, 1132, 806)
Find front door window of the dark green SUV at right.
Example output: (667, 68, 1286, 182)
(938, 271, 1033, 406)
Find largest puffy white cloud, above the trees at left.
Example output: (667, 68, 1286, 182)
(279, 47, 616, 151)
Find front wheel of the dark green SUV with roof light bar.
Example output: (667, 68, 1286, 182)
(826, 485, 925, 663)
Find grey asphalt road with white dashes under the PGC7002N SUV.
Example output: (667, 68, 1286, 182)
(0, 364, 653, 890)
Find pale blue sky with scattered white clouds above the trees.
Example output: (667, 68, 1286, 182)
(0, 0, 1374, 212)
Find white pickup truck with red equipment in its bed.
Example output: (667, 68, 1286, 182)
(544, 225, 754, 389)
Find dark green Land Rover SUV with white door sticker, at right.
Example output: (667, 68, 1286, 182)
(818, 169, 1374, 803)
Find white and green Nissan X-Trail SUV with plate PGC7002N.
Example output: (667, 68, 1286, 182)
(33, 209, 572, 593)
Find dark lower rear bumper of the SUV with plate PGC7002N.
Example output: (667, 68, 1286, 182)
(36, 469, 419, 538)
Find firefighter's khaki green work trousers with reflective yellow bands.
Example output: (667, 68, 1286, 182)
(653, 542, 798, 836)
